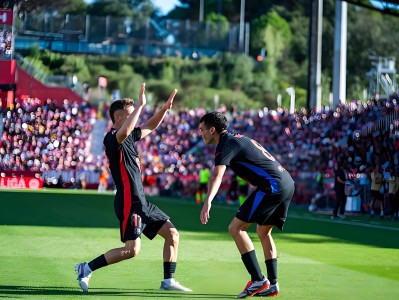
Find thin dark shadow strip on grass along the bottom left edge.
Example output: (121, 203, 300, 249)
(0, 285, 236, 299)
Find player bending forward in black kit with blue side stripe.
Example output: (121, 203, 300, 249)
(199, 112, 295, 298)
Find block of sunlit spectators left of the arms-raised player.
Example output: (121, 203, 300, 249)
(0, 98, 96, 172)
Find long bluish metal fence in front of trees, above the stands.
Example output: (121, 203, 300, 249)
(16, 13, 249, 58)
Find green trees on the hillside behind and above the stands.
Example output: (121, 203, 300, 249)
(7, 0, 399, 108)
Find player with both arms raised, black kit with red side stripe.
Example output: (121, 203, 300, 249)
(75, 83, 191, 292)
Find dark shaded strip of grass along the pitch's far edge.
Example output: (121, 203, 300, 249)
(0, 190, 399, 249)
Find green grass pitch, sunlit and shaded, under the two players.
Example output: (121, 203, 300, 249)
(0, 190, 399, 300)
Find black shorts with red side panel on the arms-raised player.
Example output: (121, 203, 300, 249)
(118, 202, 170, 243)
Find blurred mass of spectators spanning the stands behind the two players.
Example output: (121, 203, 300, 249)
(0, 94, 399, 217)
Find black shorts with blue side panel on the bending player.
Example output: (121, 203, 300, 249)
(236, 180, 295, 230)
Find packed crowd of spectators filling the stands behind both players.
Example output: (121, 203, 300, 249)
(0, 94, 399, 217)
